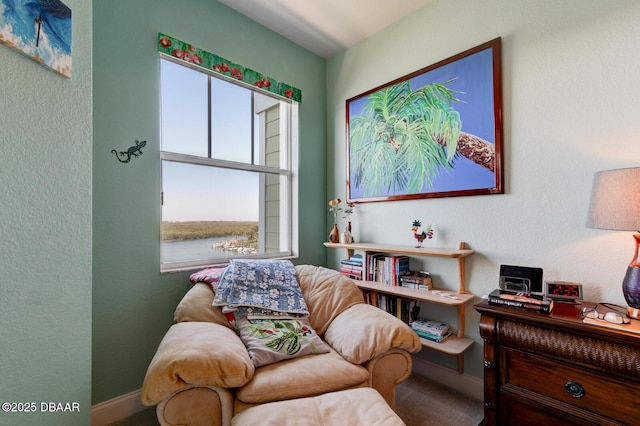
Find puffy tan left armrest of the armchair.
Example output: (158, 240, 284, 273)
(142, 322, 255, 405)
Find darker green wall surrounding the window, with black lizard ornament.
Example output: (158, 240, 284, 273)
(92, 0, 326, 404)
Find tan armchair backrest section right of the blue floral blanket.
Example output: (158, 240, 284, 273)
(296, 265, 364, 336)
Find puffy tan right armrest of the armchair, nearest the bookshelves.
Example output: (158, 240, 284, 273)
(324, 303, 422, 364)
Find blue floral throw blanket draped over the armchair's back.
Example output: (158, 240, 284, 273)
(213, 259, 309, 319)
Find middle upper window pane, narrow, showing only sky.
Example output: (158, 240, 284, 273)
(211, 78, 252, 164)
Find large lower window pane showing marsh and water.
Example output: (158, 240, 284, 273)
(161, 161, 287, 264)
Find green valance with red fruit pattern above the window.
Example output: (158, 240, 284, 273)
(158, 33, 302, 102)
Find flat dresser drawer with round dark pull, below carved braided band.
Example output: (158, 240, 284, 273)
(500, 347, 640, 424)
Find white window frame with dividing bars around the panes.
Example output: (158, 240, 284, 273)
(160, 54, 299, 273)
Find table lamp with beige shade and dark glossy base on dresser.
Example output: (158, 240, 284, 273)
(587, 167, 640, 319)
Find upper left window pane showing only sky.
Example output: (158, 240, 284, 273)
(160, 60, 209, 157)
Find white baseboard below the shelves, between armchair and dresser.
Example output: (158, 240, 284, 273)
(412, 356, 484, 401)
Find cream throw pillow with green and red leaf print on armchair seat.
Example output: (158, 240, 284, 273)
(236, 317, 329, 367)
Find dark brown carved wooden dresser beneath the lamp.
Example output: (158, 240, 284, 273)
(474, 301, 640, 426)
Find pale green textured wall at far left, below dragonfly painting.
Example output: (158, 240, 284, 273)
(0, 0, 92, 426)
